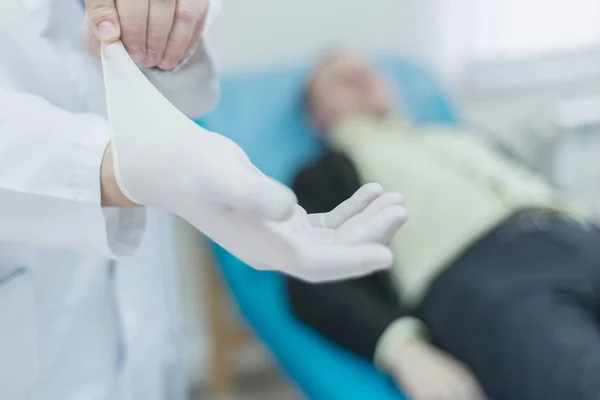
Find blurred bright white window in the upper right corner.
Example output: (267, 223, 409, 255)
(467, 0, 600, 87)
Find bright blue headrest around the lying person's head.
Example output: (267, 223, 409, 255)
(198, 55, 457, 183)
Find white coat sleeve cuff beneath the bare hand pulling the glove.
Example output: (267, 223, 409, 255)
(144, 0, 222, 118)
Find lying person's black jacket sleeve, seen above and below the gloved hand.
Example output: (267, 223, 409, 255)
(286, 151, 406, 359)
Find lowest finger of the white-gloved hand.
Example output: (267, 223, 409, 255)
(294, 244, 393, 282)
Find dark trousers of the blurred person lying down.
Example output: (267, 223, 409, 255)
(416, 212, 600, 400)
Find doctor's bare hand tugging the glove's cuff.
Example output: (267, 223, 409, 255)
(83, 0, 209, 70)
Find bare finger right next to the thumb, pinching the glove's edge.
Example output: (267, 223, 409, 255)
(116, 0, 149, 63)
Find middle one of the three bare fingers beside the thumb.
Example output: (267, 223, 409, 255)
(143, 0, 177, 67)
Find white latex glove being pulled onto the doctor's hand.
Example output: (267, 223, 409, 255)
(102, 42, 405, 281)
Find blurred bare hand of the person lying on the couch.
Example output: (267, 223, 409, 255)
(390, 338, 485, 400)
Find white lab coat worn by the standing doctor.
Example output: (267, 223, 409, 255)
(0, 0, 218, 400)
